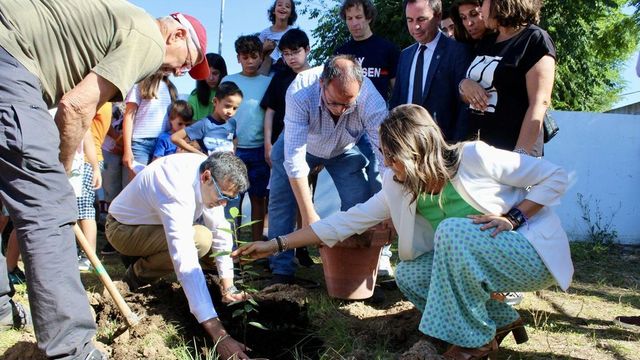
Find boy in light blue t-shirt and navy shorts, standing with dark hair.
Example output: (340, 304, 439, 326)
(221, 35, 271, 241)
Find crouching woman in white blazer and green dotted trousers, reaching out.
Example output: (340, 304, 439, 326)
(232, 105, 573, 359)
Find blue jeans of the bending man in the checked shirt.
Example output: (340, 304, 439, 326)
(269, 135, 370, 275)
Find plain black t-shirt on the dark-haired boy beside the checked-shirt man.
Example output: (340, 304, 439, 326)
(260, 66, 298, 144)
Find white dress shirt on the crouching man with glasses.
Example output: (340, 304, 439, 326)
(109, 153, 233, 322)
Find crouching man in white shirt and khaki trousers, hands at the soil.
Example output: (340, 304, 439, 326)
(105, 152, 249, 359)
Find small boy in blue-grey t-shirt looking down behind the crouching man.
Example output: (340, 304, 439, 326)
(171, 81, 242, 155)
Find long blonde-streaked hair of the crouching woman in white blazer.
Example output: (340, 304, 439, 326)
(380, 104, 464, 206)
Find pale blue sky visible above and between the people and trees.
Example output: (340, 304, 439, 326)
(130, 0, 640, 107)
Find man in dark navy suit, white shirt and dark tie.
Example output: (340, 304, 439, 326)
(389, 0, 471, 142)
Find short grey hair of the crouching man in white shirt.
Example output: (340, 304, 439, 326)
(200, 151, 249, 193)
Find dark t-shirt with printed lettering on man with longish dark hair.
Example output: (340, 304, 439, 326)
(335, 35, 400, 100)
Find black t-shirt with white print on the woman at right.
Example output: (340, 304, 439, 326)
(467, 25, 556, 150)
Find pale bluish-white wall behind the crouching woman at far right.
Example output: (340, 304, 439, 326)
(545, 111, 640, 244)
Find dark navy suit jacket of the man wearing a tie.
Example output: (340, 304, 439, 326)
(389, 35, 471, 142)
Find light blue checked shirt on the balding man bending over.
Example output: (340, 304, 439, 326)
(284, 66, 388, 178)
